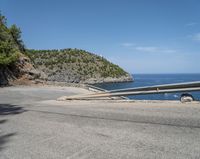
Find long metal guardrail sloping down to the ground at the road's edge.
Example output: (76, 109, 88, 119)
(60, 81, 200, 100)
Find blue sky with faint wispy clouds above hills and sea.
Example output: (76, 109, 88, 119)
(0, 0, 200, 73)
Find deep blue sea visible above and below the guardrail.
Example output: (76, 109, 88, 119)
(95, 74, 200, 100)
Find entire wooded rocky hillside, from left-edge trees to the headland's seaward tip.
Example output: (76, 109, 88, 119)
(0, 14, 132, 85)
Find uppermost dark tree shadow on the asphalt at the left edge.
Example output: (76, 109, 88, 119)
(0, 104, 26, 115)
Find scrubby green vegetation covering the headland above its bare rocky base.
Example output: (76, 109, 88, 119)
(27, 49, 127, 78)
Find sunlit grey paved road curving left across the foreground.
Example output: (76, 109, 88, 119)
(0, 87, 200, 159)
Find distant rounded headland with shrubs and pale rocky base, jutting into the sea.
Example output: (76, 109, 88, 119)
(28, 49, 132, 83)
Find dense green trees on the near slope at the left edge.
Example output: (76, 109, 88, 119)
(0, 14, 25, 67)
